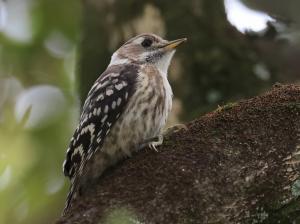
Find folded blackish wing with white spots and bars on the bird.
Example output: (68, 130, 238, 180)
(63, 65, 138, 182)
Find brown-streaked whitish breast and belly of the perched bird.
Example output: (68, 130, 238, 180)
(104, 65, 172, 158)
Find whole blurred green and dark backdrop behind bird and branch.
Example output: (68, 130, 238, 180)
(0, 0, 300, 224)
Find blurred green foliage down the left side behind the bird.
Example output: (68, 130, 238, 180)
(0, 0, 81, 224)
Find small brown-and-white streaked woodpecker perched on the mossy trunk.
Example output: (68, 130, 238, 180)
(63, 33, 187, 213)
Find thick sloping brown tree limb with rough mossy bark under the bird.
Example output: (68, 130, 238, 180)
(57, 85, 300, 224)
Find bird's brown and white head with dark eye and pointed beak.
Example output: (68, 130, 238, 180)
(110, 34, 187, 73)
